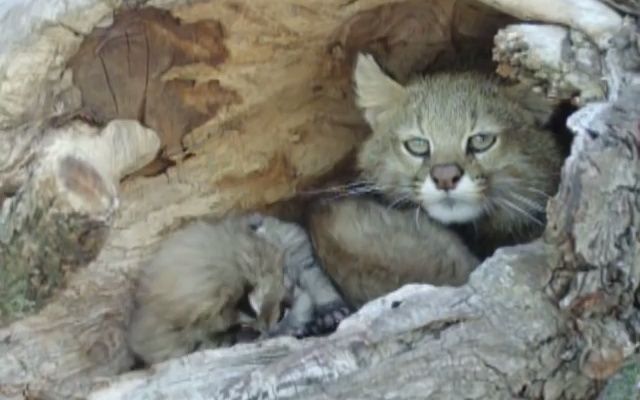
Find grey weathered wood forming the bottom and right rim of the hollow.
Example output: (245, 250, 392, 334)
(85, 7, 640, 400)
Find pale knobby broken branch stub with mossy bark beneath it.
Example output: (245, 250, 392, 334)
(0, 121, 159, 325)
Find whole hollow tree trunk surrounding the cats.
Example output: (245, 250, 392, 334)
(0, 0, 640, 400)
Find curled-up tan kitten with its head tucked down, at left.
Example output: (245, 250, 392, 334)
(128, 214, 346, 364)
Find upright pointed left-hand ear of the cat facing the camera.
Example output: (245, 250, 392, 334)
(353, 53, 407, 126)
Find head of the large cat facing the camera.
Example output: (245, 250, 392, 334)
(354, 55, 562, 228)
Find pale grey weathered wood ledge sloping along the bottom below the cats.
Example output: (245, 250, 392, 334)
(91, 243, 572, 400)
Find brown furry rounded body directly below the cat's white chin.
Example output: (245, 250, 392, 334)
(309, 199, 478, 306)
